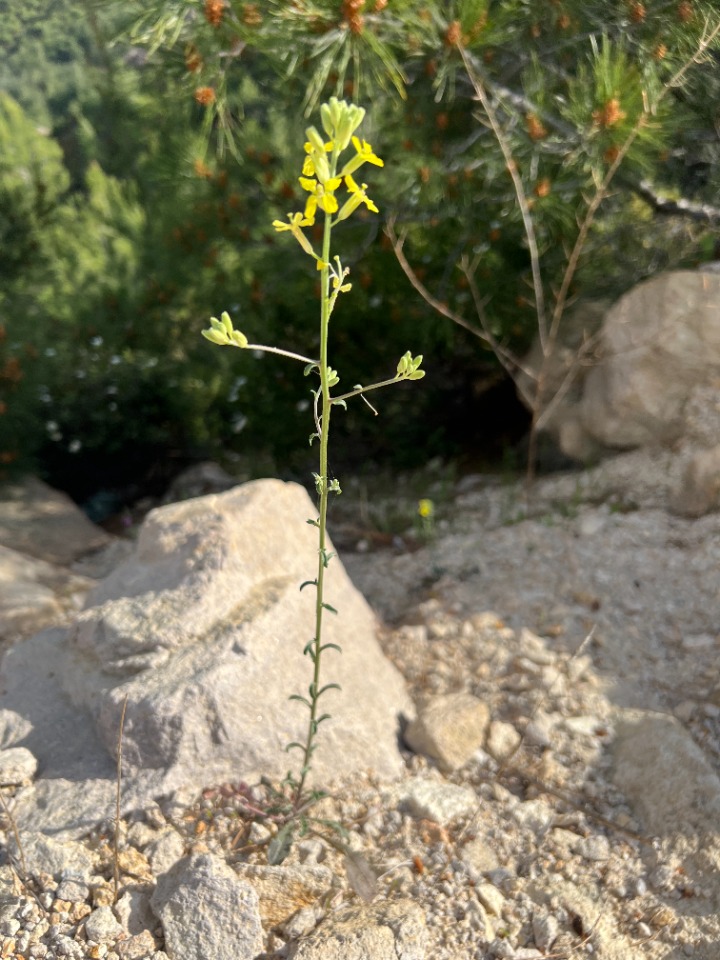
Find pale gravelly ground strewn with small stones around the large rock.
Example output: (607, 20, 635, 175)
(0, 454, 720, 960)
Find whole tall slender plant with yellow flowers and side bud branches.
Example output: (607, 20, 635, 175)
(202, 97, 425, 846)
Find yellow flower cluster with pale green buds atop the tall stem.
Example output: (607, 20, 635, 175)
(273, 97, 384, 260)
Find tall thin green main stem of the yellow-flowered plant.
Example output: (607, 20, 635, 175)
(293, 206, 332, 810)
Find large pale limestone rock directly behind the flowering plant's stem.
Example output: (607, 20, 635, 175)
(0, 480, 411, 832)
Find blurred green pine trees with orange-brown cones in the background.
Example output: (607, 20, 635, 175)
(0, 0, 720, 501)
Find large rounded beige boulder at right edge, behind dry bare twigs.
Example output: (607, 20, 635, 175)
(519, 270, 720, 461)
